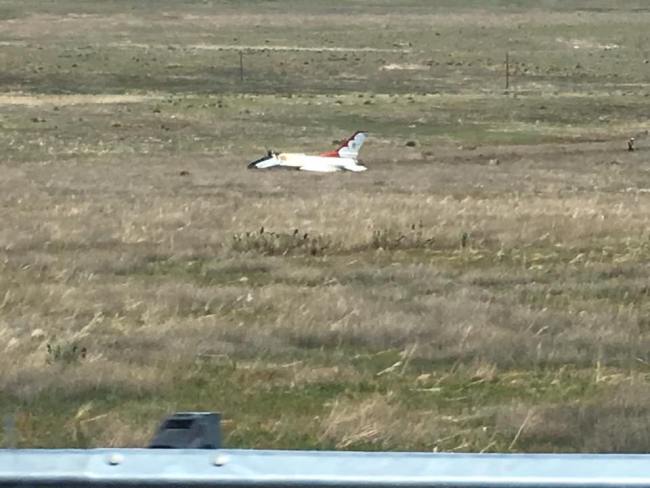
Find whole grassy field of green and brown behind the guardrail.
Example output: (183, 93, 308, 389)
(0, 0, 650, 452)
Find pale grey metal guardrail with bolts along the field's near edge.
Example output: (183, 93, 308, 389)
(0, 449, 650, 488)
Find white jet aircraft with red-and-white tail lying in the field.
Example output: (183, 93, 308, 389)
(248, 131, 368, 173)
